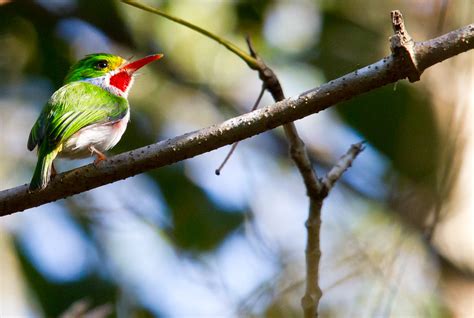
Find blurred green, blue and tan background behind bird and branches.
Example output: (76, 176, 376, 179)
(0, 0, 474, 317)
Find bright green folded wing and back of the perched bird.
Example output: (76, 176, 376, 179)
(28, 82, 128, 150)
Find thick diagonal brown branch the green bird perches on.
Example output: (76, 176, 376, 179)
(0, 24, 474, 216)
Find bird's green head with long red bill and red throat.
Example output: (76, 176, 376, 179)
(64, 53, 163, 97)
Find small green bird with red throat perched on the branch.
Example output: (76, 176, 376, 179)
(28, 53, 163, 191)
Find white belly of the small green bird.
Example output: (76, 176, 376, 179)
(59, 110, 130, 159)
